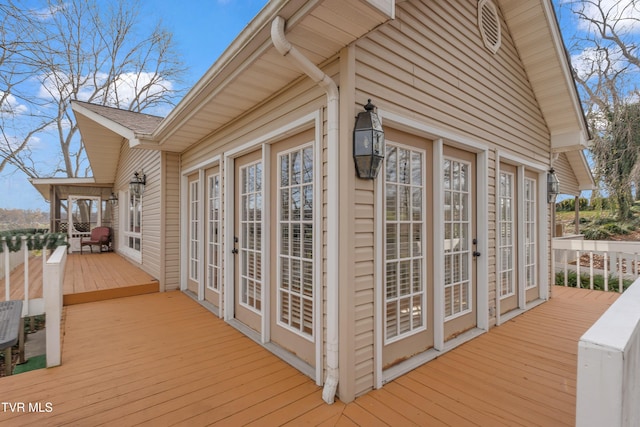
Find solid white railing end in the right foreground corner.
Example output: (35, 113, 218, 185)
(576, 279, 640, 427)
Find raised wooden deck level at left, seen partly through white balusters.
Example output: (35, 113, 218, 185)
(0, 252, 159, 305)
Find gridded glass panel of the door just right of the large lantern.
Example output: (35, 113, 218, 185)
(384, 144, 426, 342)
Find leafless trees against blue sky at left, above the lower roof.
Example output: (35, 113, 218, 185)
(0, 0, 185, 178)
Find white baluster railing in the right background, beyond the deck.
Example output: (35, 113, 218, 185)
(552, 238, 640, 292)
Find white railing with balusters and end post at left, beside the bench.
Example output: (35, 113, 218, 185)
(0, 236, 67, 367)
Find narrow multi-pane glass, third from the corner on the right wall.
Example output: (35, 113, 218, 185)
(498, 172, 516, 298)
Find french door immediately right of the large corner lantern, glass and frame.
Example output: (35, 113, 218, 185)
(378, 130, 434, 369)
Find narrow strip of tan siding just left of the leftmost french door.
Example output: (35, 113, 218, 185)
(161, 153, 180, 290)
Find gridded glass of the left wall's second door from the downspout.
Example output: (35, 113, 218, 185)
(239, 161, 263, 314)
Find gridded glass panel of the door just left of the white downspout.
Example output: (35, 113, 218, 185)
(278, 145, 315, 337)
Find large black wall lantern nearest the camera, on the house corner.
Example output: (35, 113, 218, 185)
(353, 100, 385, 179)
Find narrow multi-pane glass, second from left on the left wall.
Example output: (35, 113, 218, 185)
(207, 174, 222, 291)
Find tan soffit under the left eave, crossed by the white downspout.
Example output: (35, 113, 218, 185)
(153, 0, 394, 152)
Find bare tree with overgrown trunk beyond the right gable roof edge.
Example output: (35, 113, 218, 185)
(561, 0, 640, 219)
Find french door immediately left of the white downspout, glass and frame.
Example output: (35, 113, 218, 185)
(269, 131, 321, 367)
